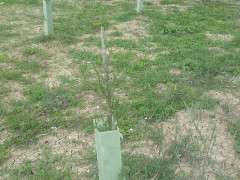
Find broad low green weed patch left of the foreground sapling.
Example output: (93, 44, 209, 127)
(1, 84, 80, 145)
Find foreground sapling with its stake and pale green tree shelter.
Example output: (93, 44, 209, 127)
(93, 27, 122, 180)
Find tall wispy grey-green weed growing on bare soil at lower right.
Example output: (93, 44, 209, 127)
(165, 111, 216, 179)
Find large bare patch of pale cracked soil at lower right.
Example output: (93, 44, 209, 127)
(156, 109, 240, 179)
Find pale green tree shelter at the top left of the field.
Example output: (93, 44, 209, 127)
(43, 0, 53, 35)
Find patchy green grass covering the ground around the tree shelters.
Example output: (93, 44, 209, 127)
(0, 0, 240, 179)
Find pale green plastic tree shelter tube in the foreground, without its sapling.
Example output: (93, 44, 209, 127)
(93, 118, 122, 180)
